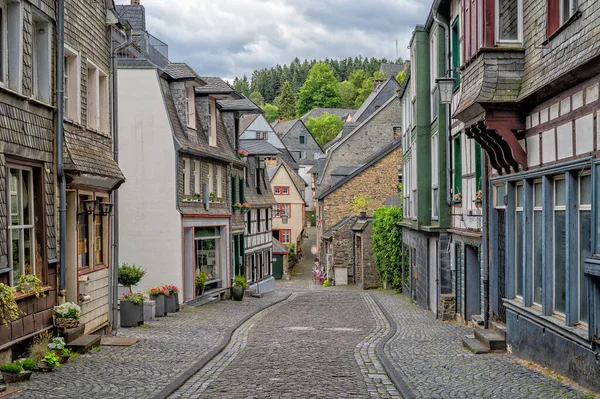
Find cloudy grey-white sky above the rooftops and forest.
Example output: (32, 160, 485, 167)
(116, 0, 431, 80)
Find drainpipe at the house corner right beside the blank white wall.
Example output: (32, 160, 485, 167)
(111, 23, 131, 334)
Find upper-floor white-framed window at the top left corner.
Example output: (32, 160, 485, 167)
(0, 0, 23, 93)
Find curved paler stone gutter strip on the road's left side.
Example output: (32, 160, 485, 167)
(169, 294, 297, 399)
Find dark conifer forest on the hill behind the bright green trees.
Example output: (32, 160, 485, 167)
(233, 56, 402, 103)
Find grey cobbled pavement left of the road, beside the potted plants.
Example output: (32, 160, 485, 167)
(11, 292, 287, 399)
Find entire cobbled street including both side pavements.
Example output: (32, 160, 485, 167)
(7, 228, 593, 399)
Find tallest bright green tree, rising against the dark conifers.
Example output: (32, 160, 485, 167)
(297, 62, 342, 115)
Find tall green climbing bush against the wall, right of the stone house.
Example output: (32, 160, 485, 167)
(372, 207, 403, 292)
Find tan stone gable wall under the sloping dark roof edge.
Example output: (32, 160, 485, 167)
(323, 148, 402, 231)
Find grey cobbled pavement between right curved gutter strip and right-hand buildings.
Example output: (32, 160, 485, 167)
(374, 291, 585, 399)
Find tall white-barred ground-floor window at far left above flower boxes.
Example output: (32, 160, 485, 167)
(8, 165, 36, 285)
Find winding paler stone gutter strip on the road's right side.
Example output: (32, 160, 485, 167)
(354, 294, 401, 398)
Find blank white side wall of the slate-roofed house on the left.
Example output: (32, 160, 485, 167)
(118, 69, 183, 301)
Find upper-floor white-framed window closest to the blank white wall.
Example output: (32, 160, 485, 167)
(87, 60, 109, 133)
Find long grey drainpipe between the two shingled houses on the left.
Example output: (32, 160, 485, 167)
(56, 0, 67, 293)
